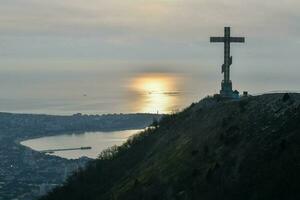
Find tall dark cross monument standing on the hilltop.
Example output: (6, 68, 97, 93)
(210, 27, 245, 98)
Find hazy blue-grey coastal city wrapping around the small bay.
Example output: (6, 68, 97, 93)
(0, 113, 157, 200)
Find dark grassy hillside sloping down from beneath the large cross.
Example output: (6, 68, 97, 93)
(42, 94, 300, 200)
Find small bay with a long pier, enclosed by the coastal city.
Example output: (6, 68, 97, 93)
(21, 130, 142, 159)
